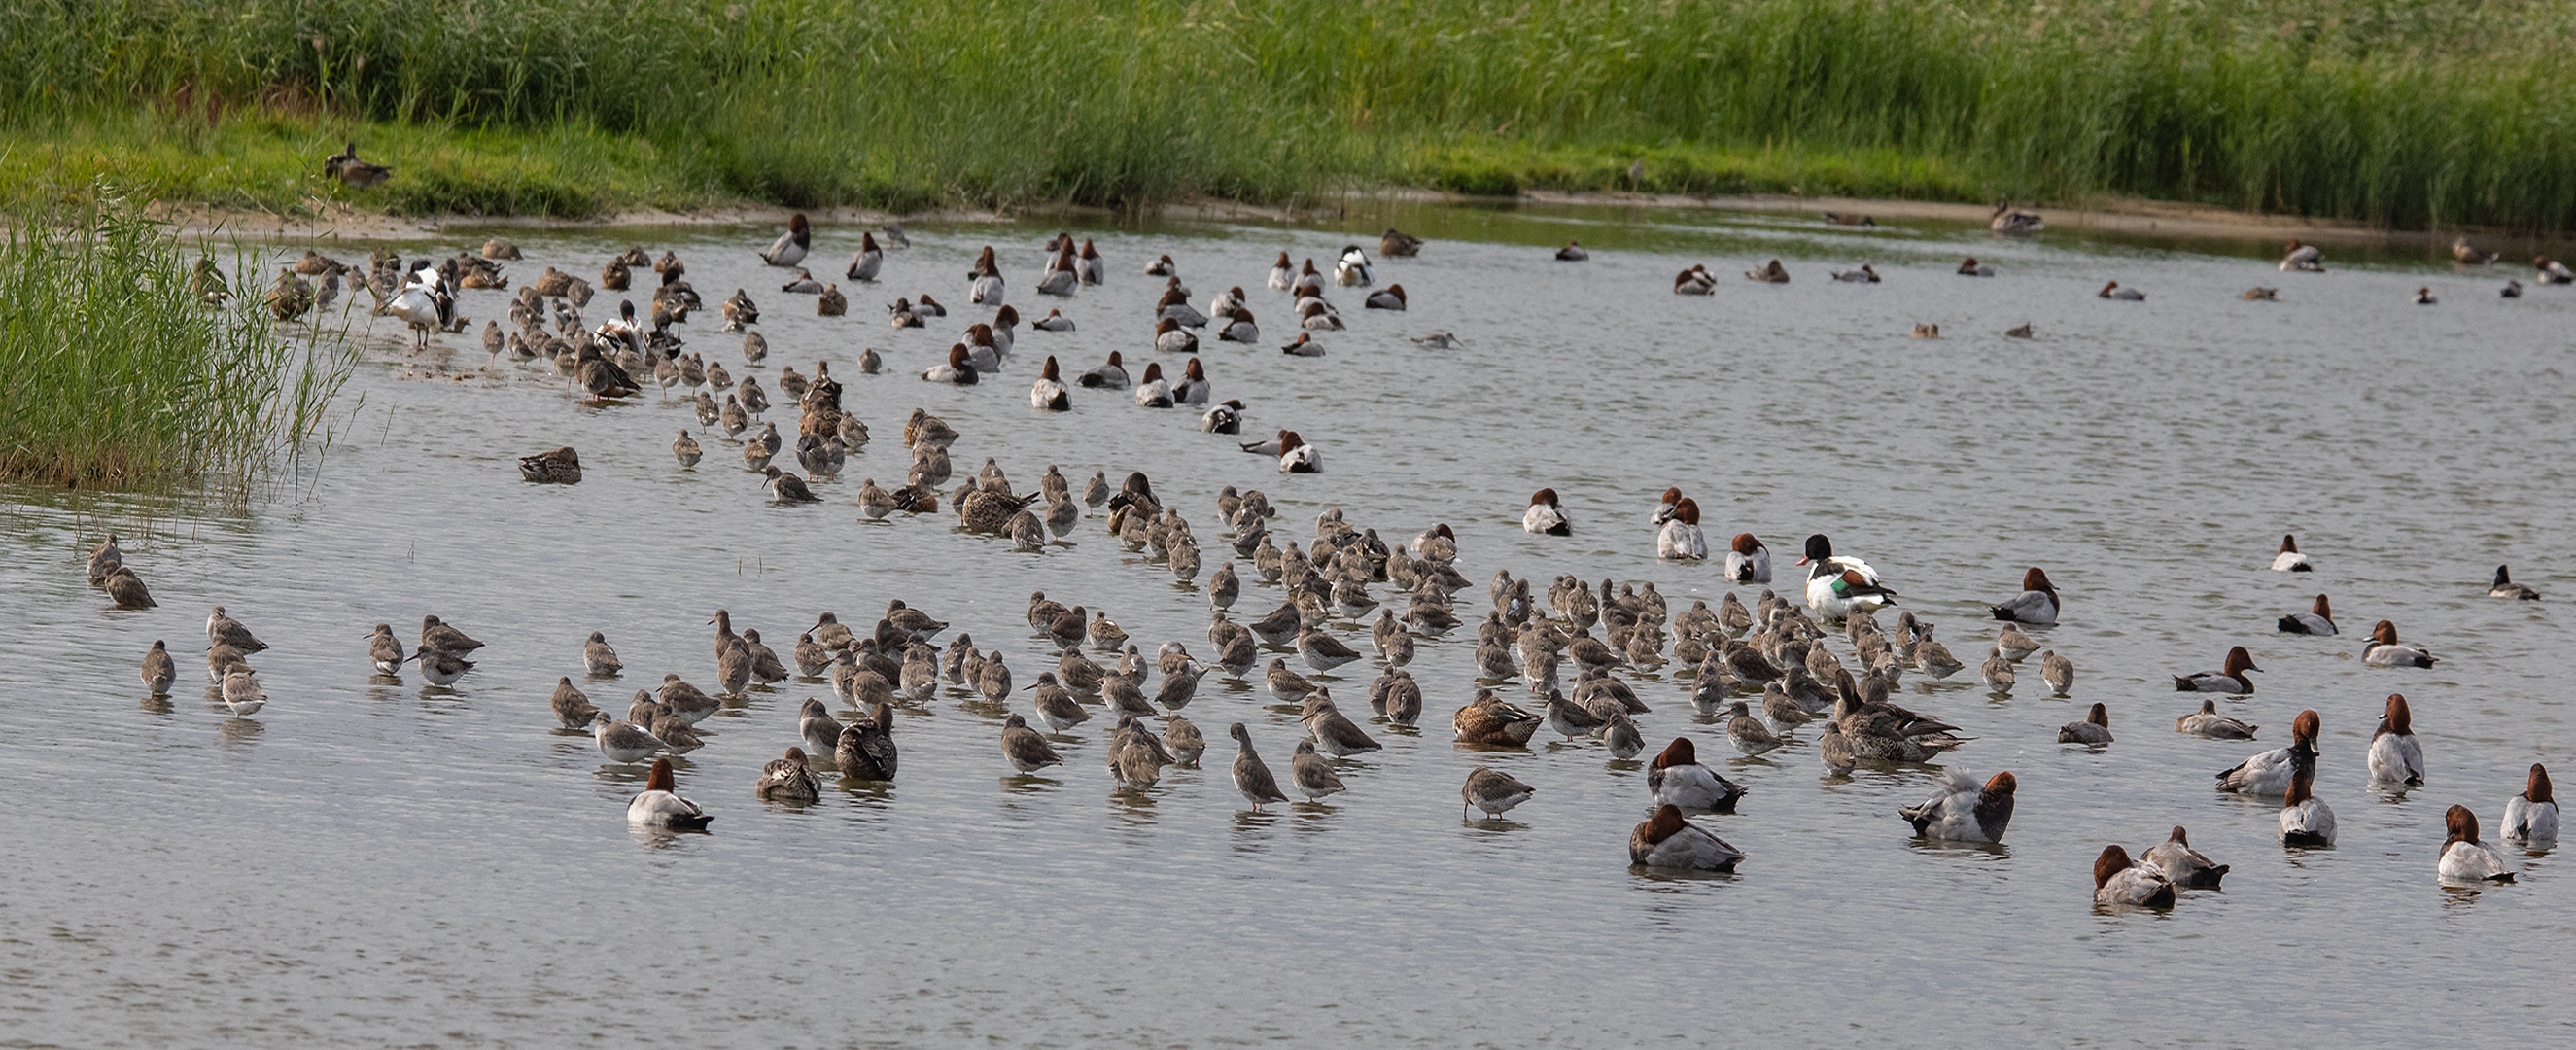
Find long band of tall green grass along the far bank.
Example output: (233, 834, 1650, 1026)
(0, 0, 2576, 231)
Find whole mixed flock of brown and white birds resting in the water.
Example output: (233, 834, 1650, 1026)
(105, 206, 2571, 906)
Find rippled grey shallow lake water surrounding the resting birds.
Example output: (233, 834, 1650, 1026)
(0, 208, 2576, 1047)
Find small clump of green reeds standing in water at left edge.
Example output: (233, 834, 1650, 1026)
(0, 193, 353, 500)
